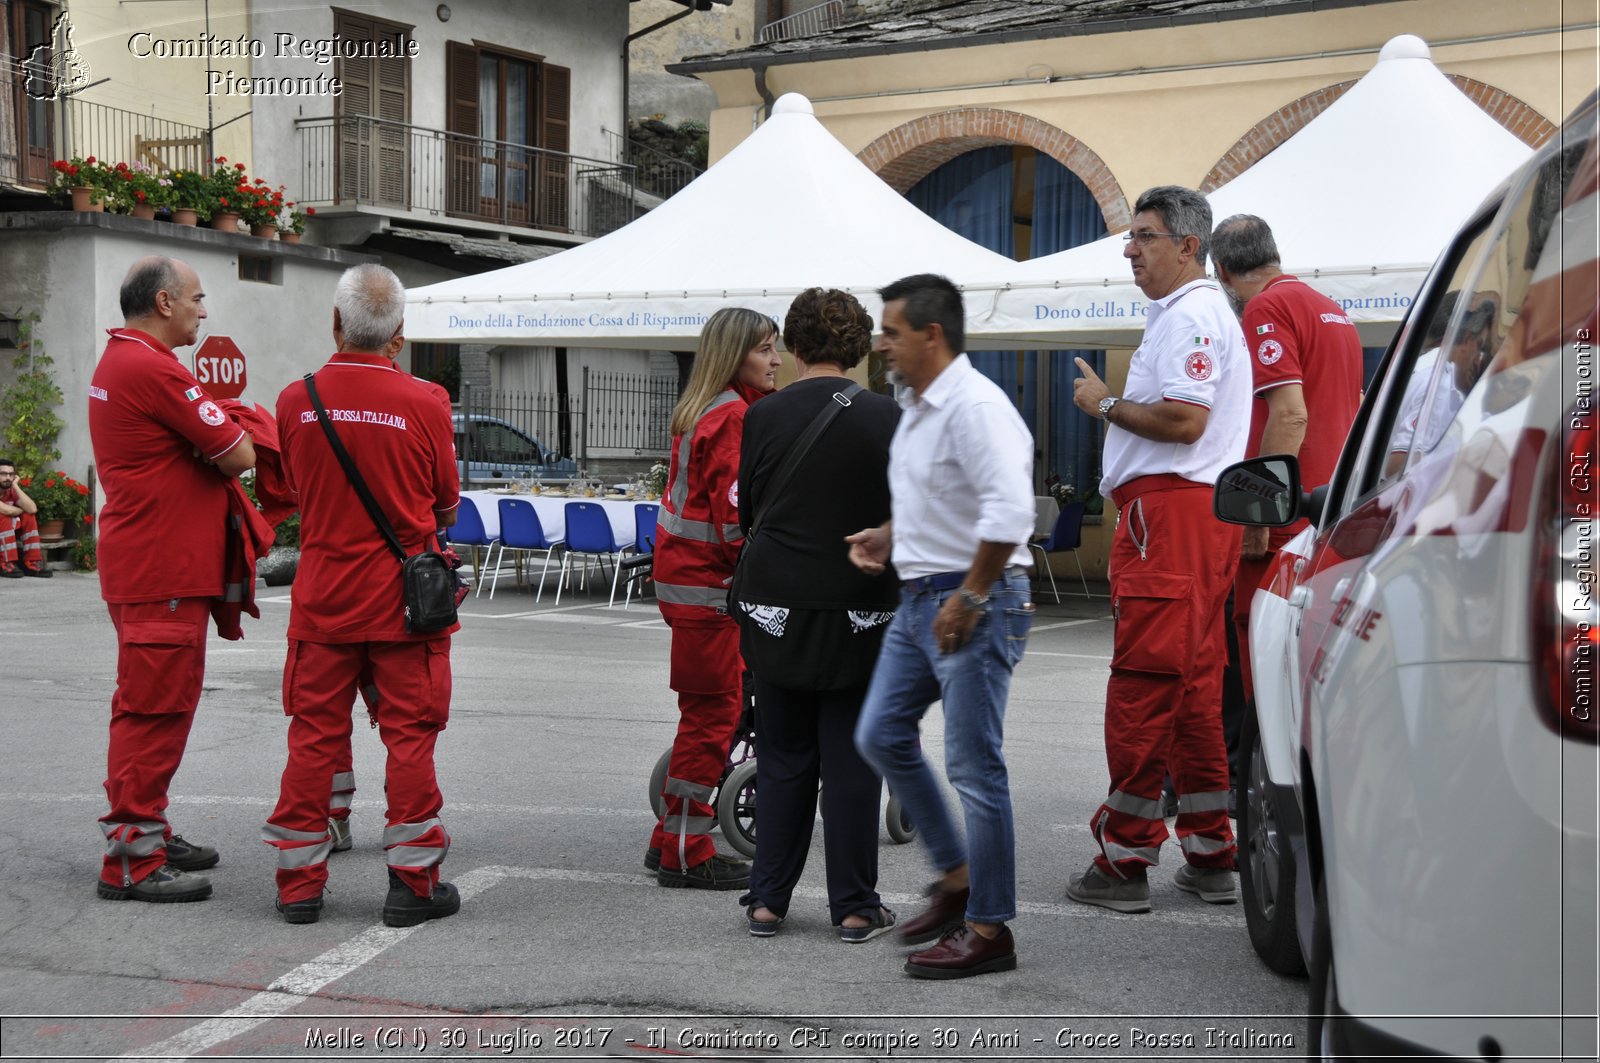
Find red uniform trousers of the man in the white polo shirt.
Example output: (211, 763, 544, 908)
(1090, 475, 1240, 877)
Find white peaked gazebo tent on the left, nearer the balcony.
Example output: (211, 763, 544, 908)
(406, 93, 1014, 351)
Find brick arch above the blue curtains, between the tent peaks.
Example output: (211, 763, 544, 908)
(856, 107, 1133, 232)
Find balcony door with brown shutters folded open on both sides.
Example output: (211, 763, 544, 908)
(445, 42, 571, 229)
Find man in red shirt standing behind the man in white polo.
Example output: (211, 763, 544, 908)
(1211, 215, 1362, 714)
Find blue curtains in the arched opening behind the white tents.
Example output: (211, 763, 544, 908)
(906, 147, 1106, 495)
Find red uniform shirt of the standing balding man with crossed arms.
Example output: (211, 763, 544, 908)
(90, 328, 245, 602)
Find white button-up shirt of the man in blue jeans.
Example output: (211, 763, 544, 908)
(890, 354, 1036, 580)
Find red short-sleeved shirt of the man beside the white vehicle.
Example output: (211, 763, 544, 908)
(1245, 274, 1362, 488)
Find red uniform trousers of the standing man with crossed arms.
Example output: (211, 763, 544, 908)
(101, 599, 211, 887)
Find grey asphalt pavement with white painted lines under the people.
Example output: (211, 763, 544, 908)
(0, 573, 1306, 1060)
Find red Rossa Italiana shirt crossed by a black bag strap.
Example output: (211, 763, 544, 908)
(278, 354, 461, 642)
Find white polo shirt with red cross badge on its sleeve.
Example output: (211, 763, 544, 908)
(1101, 277, 1251, 498)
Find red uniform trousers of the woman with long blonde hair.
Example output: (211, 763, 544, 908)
(650, 610, 744, 871)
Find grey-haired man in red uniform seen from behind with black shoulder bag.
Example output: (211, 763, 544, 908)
(261, 266, 461, 927)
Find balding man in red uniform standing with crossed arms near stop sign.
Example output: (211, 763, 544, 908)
(90, 256, 256, 901)
